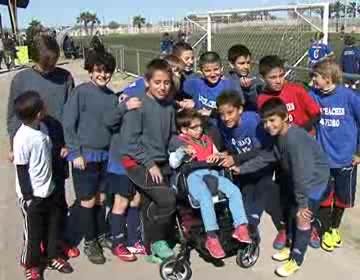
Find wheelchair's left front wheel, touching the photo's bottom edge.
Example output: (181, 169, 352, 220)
(160, 257, 192, 280)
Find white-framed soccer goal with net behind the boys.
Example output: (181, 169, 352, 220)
(198, 3, 329, 79)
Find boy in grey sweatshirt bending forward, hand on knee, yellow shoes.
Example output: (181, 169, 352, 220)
(235, 98, 330, 277)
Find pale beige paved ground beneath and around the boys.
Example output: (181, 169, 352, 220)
(0, 63, 360, 280)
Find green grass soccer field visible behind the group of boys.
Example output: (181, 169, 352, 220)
(77, 30, 360, 81)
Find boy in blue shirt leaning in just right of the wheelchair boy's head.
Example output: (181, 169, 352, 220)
(217, 91, 274, 237)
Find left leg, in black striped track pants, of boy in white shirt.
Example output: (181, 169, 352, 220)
(19, 198, 44, 268)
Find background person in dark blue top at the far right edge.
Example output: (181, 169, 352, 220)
(341, 35, 360, 89)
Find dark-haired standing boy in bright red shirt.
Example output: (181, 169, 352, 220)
(257, 55, 320, 249)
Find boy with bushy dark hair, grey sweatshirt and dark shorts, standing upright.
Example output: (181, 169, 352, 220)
(63, 47, 118, 264)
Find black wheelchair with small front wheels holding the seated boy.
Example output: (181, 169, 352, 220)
(160, 162, 260, 280)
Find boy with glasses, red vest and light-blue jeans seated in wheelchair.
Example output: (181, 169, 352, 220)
(169, 110, 252, 259)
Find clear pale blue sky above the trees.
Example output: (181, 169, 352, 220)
(0, 0, 296, 28)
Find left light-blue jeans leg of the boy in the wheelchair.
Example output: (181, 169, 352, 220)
(187, 170, 219, 232)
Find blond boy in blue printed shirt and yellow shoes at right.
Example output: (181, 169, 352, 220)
(310, 61, 360, 252)
